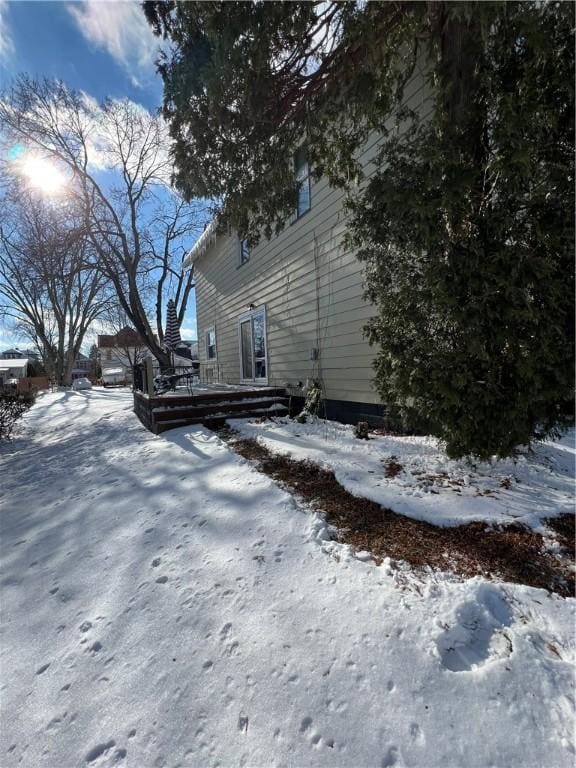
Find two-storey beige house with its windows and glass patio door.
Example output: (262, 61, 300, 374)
(186, 75, 427, 422)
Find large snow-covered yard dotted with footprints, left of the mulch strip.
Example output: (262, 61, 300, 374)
(0, 389, 575, 768)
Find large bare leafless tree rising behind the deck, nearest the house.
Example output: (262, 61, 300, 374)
(0, 76, 204, 365)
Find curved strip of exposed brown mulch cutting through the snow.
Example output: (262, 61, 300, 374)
(220, 430, 574, 596)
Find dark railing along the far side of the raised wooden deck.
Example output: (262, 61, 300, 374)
(133, 359, 223, 396)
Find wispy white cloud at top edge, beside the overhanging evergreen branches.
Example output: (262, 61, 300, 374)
(67, 0, 159, 87)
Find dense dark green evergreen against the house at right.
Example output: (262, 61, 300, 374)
(350, 4, 574, 457)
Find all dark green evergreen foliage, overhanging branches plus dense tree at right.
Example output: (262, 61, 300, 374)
(144, 0, 574, 457)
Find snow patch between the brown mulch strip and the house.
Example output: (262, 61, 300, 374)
(230, 418, 576, 533)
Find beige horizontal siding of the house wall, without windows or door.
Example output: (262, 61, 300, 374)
(195, 70, 432, 403)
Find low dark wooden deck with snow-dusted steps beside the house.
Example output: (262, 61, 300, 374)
(134, 384, 288, 435)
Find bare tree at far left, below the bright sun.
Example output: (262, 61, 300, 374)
(0, 188, 109, 384)
